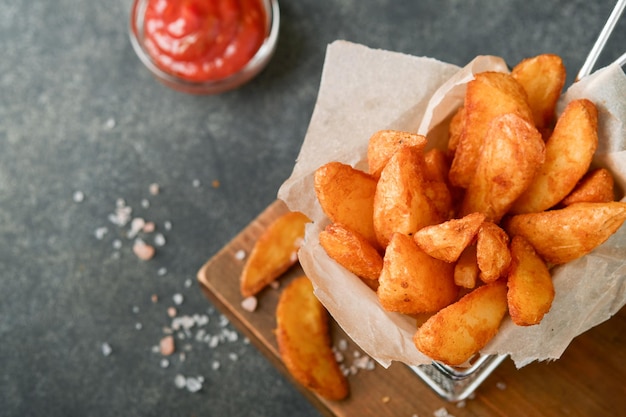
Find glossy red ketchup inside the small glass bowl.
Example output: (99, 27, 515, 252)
(144, 0, 267, 82)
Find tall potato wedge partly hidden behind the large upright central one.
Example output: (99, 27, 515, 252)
(449, 72, 533, 188)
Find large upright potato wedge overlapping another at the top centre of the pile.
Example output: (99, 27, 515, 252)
(460, 113, 545, 223)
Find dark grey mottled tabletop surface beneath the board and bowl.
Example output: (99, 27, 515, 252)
(0, 0, 626, 417)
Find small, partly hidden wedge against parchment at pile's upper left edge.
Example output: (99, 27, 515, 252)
(367, 130, 426, 178)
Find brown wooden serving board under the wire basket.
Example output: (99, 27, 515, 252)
(198, 201, 626, 417)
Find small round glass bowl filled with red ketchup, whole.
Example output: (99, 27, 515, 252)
(130, 0, 280, 94)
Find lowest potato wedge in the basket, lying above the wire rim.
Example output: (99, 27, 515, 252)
(413, 280, 507, 366)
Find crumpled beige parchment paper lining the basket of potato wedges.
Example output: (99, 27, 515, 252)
(278, 41, 626, 367)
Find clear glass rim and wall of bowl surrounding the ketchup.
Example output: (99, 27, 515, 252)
(129, 0, 280, 94)
